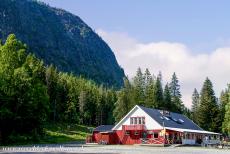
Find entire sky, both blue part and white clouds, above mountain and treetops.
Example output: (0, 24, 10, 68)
(42, 0, 230, 107)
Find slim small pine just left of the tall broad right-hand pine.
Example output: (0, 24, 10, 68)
(191, 88, 200, 123)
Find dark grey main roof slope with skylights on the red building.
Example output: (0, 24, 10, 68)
(139, 106, 203, 130)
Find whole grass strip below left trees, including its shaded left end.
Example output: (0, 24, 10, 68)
(3, 124, 93, 146)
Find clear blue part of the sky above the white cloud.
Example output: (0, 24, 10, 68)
(43, 0, 230, 52)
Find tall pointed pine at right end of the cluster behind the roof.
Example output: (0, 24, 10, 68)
(169, 72, 183, 113)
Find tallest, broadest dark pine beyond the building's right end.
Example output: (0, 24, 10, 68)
(197, 78, 221, 132)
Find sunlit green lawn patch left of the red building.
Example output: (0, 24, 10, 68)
(39, 124, 93, 143)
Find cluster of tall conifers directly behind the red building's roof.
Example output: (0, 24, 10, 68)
(114, 68, 190, 121)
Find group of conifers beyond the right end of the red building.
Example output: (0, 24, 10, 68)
(191, 78, 230, 135)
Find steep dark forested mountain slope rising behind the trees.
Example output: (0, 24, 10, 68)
(0, 0, 124, 87)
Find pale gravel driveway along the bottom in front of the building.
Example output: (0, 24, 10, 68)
(0, 145, 230, 154)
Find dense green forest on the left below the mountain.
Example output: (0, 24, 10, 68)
(0, 34, 117, 144)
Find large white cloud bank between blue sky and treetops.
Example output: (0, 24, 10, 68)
(97, 29, 230, 107)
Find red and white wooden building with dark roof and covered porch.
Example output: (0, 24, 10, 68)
(87, 105, 220, 145)
